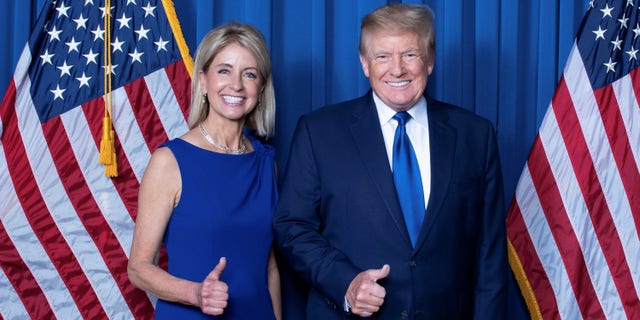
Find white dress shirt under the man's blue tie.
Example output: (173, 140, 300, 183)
(373, 92, 431, 208)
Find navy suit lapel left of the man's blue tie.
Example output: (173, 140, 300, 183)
(351, 92, 411, 246)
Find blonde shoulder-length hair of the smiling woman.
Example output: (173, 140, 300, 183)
(189, 22, 276, 139)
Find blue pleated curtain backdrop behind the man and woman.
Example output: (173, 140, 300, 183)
(0, 0, 587, 319)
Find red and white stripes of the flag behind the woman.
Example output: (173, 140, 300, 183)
(0, 41, 190, 319)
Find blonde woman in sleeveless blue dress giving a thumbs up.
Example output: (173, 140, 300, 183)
(128, 23, 281, 319)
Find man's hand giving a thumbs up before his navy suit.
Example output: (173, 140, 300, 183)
(347, 264, 391, 317)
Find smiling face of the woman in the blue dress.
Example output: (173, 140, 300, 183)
(198, 43, 264, 121)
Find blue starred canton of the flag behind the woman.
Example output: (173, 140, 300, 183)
(29, 0, 182, 122)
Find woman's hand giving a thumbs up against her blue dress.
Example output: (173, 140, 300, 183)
(199, 257, 229, 316)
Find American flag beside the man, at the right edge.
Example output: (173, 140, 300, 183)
(507, 0, 640, 319)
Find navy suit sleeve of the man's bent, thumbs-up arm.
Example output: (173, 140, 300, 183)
(273, 117, 361, 308)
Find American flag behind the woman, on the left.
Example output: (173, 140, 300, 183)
(0, 0, 193, 319)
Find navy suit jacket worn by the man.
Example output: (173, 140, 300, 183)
(274, 91, 508, 320)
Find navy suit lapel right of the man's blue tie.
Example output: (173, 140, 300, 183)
(416, 97, 457, 251)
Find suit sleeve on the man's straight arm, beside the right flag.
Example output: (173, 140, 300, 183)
(474, 122, 509, 319)
